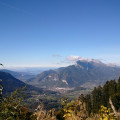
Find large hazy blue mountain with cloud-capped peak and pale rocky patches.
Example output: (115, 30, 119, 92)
(27, 60, 120, 88)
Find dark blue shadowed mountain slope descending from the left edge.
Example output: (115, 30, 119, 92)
(0, 71, 55, 96)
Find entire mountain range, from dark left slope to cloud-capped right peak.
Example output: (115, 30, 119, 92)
(0, 59, 120, 92)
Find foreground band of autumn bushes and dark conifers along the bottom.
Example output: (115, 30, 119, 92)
(0, 78, 120, 120)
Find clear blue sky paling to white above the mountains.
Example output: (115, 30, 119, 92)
(0, 0, 120, 67)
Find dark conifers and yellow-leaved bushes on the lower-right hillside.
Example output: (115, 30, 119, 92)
(57, 78, 120, 120)
